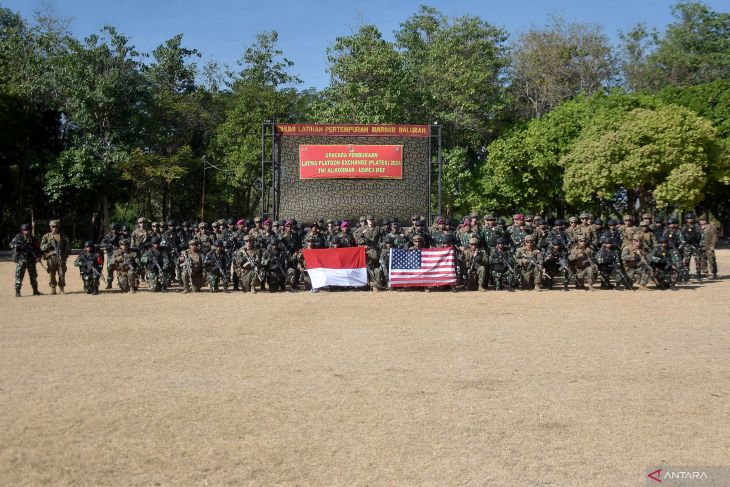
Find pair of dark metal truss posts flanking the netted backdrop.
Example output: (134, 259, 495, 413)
(260, 121, 443, 224)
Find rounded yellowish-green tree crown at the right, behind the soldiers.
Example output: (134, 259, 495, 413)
(561, 105, 730, 212)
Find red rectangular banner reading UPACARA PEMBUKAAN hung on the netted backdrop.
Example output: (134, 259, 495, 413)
(299, 145, 403, 179)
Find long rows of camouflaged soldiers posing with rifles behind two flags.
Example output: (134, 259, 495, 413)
(11, 213, 718, 296)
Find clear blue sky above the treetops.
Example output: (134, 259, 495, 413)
(5, 0, 728, 89)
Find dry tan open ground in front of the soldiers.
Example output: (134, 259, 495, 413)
(0, 250, 730, 486)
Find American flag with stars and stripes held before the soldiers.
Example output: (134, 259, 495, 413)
(388, 247, 456, 287)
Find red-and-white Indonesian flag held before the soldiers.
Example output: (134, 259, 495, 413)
(302, 247, 368, 289)
